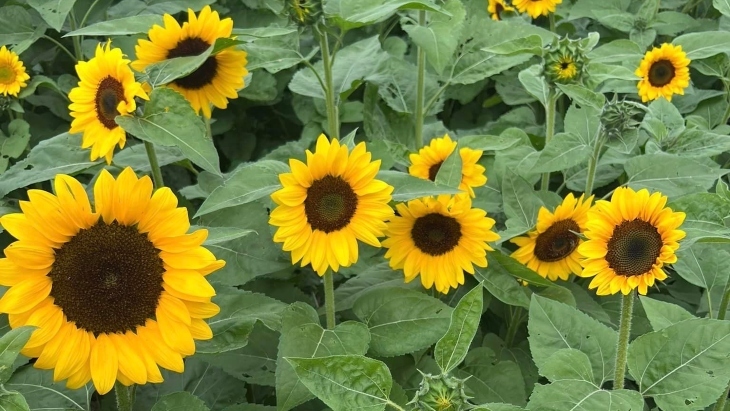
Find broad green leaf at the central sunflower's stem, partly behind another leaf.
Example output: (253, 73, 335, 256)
(276, 302, 370, 411)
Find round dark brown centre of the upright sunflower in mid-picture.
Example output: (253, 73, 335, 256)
(304, 175, 357, 233)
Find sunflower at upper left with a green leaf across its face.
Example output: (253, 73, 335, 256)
(132, 6, 248, 118)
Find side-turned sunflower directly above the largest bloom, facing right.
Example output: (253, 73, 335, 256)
(68, 42, 149, 164)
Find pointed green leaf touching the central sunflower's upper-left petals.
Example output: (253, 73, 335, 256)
(193, 160, 289, 218)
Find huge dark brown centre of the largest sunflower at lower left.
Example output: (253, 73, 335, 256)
(48, 220, 165, 334)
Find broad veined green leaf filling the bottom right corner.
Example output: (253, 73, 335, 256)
(628, 318, 730, 411)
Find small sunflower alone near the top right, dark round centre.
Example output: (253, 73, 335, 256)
(635, 43, 690, 102)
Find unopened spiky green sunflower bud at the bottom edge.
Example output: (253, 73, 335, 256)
(409, 373, 471, 411)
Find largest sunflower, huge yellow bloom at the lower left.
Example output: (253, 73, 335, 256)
(0, 168, 225, 394)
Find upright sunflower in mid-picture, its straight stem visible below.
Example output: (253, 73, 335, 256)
(269, 134, 393, 276)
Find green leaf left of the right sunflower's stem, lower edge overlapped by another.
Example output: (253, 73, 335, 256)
(527, 294, 618, 387)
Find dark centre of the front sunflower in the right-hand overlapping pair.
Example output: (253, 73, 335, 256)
(606, 218, 663, 277)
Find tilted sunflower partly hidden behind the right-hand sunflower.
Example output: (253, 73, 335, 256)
(510, 193, 593, 281)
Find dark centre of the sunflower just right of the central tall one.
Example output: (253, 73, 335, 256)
(411, 213, 461, 256)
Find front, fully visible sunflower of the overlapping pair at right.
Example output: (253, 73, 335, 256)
(578, 187, 685, 295)
